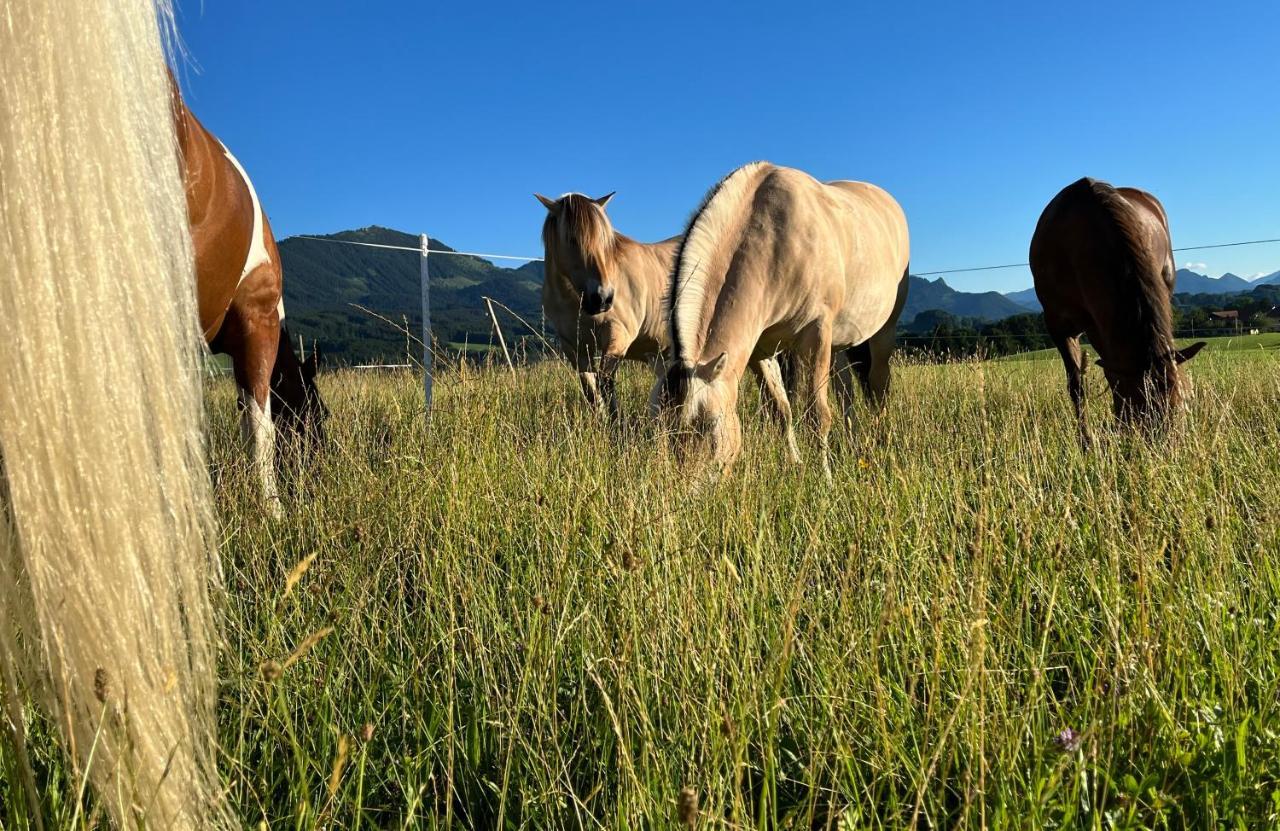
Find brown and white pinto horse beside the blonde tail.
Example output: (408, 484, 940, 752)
(170, 79, 325, 511)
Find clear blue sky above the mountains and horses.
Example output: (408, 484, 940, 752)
(178, 0, 1280, 291)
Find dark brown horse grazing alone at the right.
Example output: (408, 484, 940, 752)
(1030, 178, 1204, 444)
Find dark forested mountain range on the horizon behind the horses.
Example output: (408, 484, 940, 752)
(279, 225, 1280, 364)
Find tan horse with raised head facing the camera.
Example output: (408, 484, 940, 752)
(534, 193, 797, 453)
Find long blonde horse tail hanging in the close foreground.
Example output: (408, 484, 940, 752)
(0, 0, 230, 828)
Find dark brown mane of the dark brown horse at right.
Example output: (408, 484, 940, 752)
(1080, 178, 1174, 364)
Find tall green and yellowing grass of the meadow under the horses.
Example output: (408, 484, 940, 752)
(0, 350, 1280, 828)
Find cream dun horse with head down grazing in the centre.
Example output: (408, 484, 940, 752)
(655, 161, 909, 480)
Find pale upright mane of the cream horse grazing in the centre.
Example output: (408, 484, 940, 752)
(669, 161, 773, 364)
